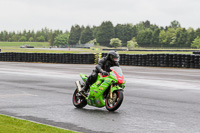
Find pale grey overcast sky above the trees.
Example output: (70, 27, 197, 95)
(0, 0, 200, 31)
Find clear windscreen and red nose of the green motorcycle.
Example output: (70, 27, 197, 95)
(110, 66, 124, 84)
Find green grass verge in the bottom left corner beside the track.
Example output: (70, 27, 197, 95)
(0, 115, 76, 133)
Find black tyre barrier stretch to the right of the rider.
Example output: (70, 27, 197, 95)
(102, 53, 200, 68)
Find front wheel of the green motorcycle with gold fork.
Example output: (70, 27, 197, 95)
(106, 90, 124, 111)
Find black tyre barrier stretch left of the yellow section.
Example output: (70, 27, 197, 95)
(0, 53, 94, 64)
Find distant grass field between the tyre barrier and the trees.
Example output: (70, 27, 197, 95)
(0, 42, 197, 54)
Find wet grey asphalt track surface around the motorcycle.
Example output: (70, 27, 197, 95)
(0, 62, 200, 133)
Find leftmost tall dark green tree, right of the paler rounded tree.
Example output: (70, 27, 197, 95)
(69, 25, 81, 45)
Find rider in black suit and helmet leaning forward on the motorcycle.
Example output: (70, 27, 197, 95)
(81, 51, 120, 92)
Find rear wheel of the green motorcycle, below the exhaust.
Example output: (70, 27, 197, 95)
(72, 89, 87, 108)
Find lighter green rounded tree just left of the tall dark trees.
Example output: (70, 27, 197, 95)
(54, 34, 69, 46)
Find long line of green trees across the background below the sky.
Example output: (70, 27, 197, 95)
(0, 20, 200, 48)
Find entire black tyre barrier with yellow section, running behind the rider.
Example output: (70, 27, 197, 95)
(0, 52, 200, 68)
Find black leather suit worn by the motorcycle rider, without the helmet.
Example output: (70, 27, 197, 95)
(86, 56, 119, 86)
